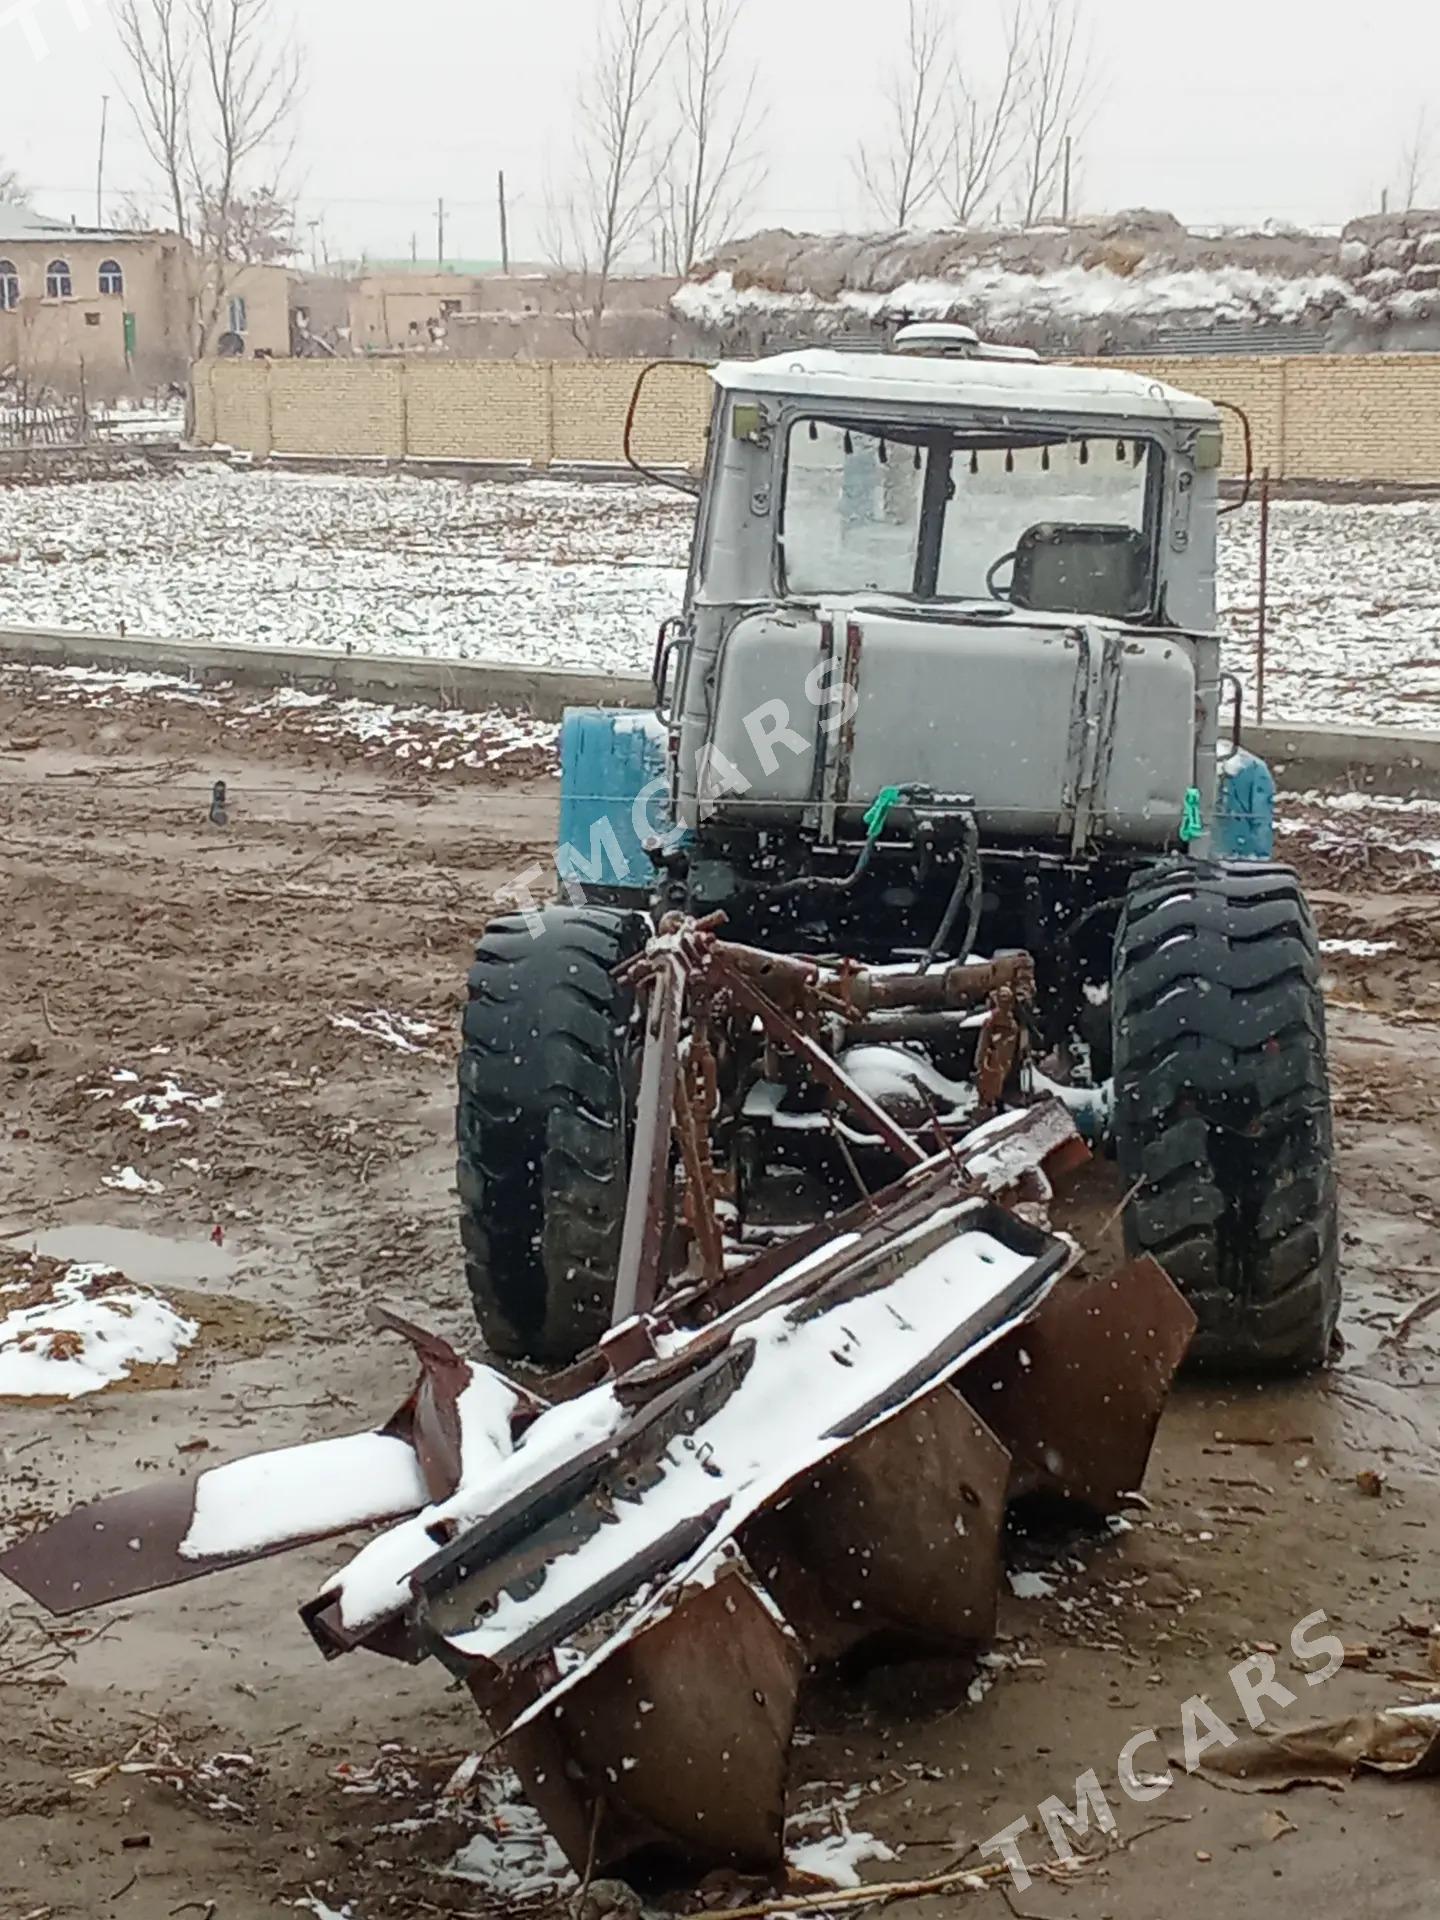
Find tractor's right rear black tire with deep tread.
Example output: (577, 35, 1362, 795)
(1112, 862, 1340, 1373)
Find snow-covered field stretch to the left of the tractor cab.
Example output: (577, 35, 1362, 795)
(0, 467, 693, 672)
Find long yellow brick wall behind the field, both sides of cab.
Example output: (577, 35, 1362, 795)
(196, 353, 1440, 486)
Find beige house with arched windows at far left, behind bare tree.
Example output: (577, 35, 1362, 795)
(0, 205, 292, 399)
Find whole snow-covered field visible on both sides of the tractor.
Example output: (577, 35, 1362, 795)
(0, 467, 1440, 728)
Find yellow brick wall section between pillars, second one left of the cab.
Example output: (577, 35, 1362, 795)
(403, 361, 551, 467)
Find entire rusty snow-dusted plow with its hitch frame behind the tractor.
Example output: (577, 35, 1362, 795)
(0, 922, 1194, 1872)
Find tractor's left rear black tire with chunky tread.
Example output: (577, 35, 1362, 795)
(455, 906, 651, 1363)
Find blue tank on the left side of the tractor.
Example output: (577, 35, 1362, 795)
(555, 707, 672, 893)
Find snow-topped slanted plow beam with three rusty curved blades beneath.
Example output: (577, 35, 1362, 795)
(395, 1196, 1194, 1872)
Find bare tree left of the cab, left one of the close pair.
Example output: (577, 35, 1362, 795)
(547, 0, 676, 353)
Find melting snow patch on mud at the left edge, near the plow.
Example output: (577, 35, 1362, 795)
(0, 1260, 200, 1400)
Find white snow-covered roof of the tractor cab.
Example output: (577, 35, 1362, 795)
(712, 348, 1219, 426)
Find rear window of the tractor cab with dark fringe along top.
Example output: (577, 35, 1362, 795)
(781, 419, 1160, 618)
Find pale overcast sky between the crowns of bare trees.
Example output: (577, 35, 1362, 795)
(11, 0, 1440, 257)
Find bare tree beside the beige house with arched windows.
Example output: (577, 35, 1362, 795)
(115, 0, 301, 353)
